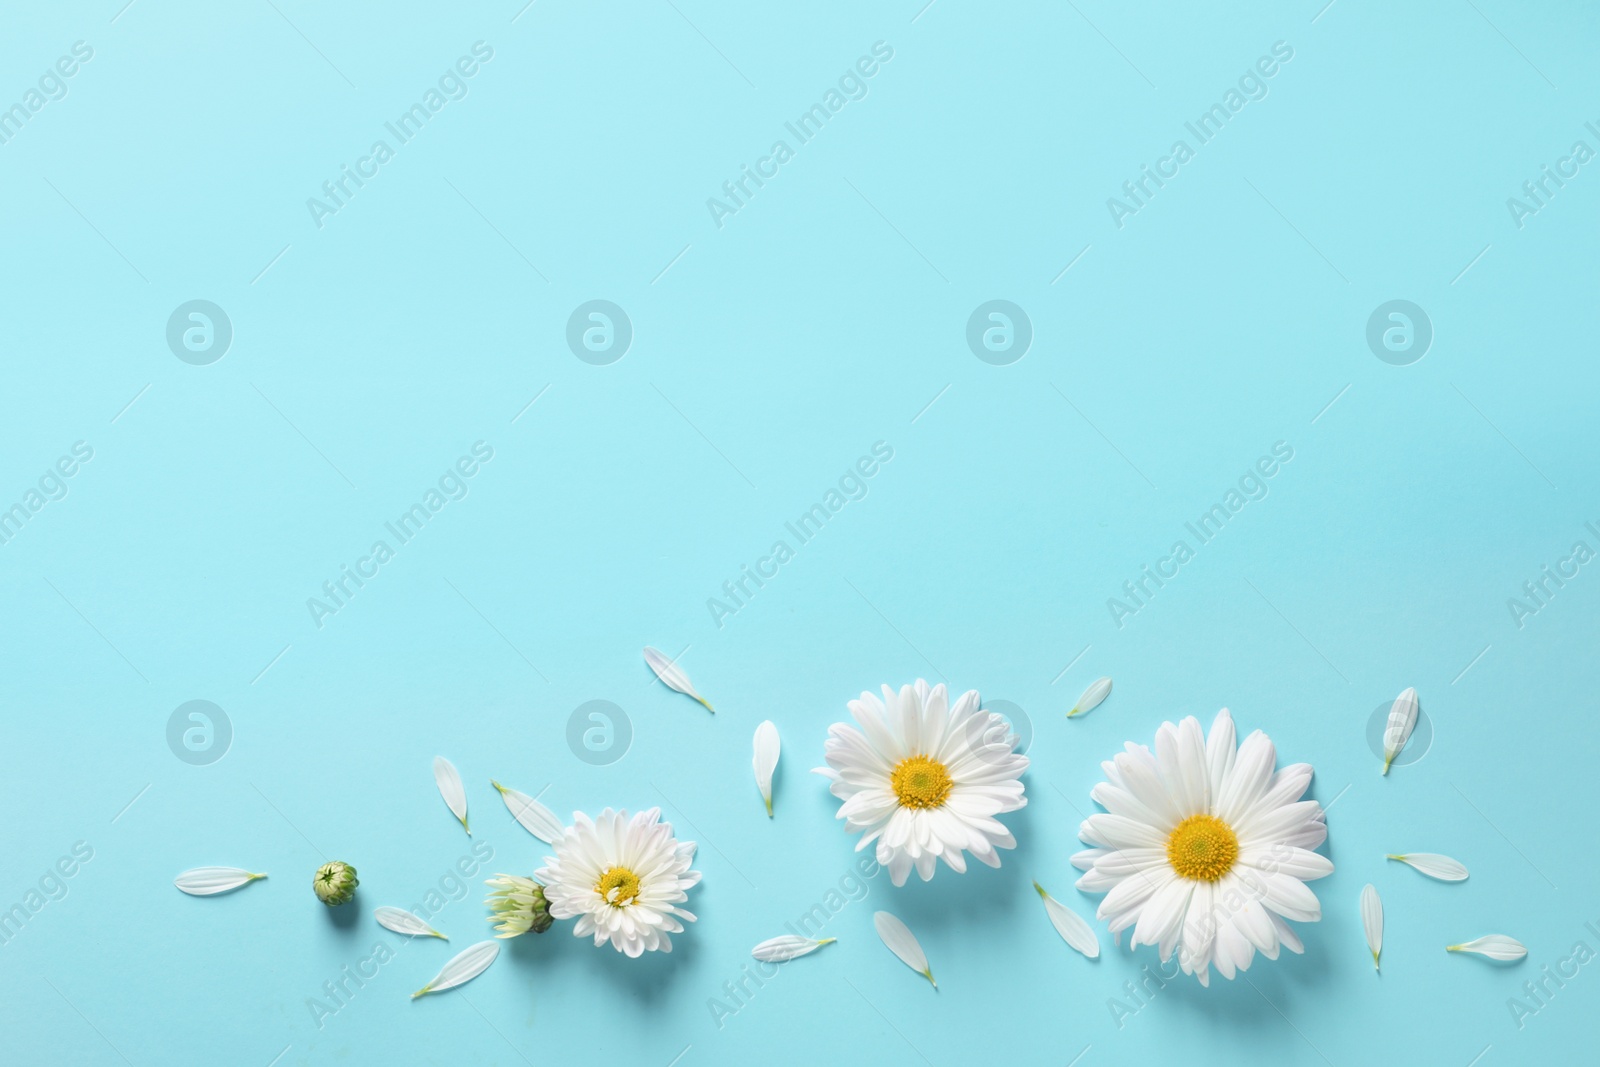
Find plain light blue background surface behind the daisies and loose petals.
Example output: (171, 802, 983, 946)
(0, 0, 1600, 1067)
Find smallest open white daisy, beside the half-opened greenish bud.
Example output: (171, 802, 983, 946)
(533, 808, 701, 957)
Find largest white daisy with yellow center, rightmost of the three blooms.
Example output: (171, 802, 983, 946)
(1072, 707, 1333, 985)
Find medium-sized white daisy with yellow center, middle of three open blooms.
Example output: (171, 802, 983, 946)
(816, 678, 1027, 886)
